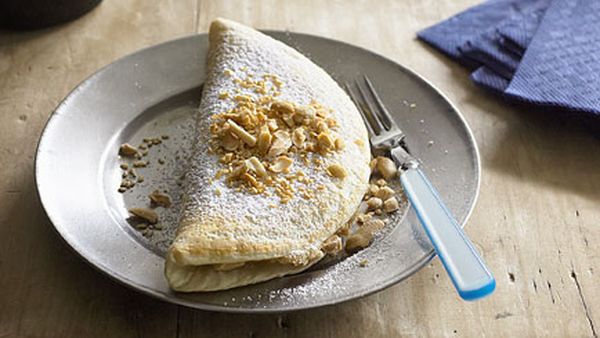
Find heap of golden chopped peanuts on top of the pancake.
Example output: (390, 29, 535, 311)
(209, 71, 346, 203)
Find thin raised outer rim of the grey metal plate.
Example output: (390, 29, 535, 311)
(33, 30, 482, 314)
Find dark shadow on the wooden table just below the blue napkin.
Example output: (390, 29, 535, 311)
(467, 85, 600, 202)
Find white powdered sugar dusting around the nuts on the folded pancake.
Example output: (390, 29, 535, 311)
(174, 19, 370, 263)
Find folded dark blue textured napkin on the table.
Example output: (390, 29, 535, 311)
(417, 0, 600, 120)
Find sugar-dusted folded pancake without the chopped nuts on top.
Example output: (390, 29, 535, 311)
(165, 19, 370, 292)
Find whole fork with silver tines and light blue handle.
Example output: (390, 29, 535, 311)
(345, 76, 496, 300)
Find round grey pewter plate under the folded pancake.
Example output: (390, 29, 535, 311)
(36, 32, 480, 313)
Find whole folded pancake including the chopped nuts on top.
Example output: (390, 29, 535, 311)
(165, 19, 370, 292)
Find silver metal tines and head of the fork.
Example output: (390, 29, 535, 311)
(345, 75, 404, 150)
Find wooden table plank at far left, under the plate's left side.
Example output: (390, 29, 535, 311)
(0, 0, 195, 337)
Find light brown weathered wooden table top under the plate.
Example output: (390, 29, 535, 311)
(0, 0, 600, 337)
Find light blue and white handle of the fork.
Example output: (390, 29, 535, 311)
(400, 167, 496, 300)
